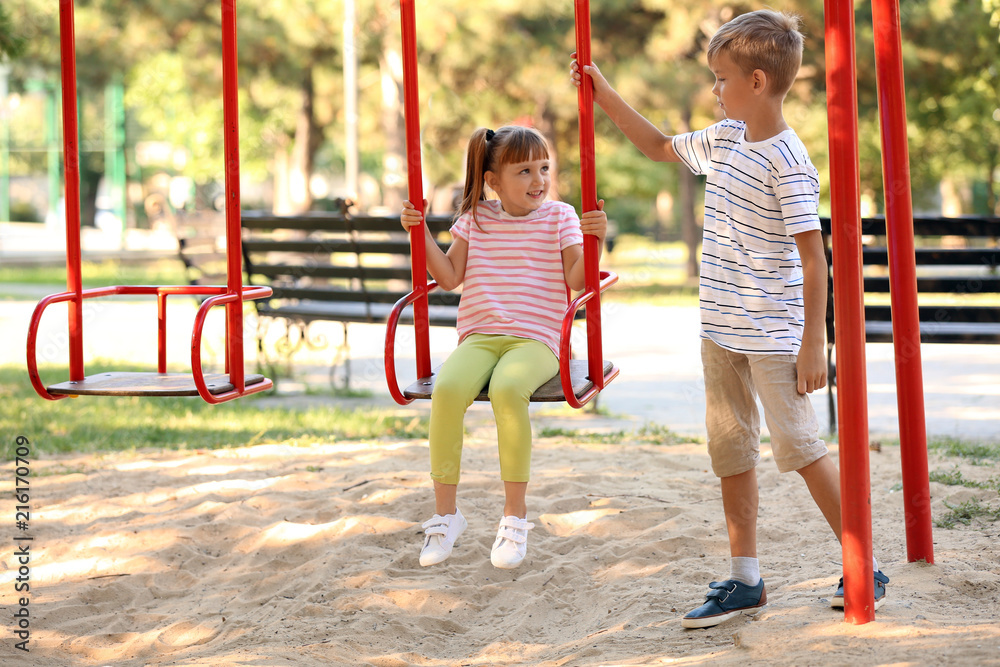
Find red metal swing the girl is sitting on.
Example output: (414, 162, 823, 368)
(385, 0, 619, 408)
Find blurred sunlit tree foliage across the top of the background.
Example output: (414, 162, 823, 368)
(0, 0, 1000, 217)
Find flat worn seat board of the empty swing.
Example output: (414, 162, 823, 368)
(47, 372, 271, 396)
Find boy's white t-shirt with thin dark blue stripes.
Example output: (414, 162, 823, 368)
(673, 120, 820, 354)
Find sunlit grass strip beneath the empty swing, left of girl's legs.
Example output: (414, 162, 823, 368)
(0, 362, 427, 459)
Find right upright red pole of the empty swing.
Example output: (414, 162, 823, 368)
(222, 0, 246, 393)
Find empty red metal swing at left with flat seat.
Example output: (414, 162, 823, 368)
(27, 0, 273, 403)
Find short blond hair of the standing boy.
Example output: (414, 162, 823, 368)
(708, 9, 803, 97)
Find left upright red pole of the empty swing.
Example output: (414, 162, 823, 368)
(59, 0, 84, 382)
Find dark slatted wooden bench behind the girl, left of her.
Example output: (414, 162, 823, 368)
(242, 210, 460, 387)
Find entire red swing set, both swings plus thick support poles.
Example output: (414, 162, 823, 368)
(27, 0, 934, 623)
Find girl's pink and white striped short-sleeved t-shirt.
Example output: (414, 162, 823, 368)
(451, 200, 583, 357)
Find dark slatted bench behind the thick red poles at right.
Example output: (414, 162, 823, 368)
(821, 216, 1000, 430)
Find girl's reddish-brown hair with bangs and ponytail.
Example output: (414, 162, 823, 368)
(456, 125, 549, 226)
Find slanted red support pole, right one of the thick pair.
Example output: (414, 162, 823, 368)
(872, 0, 934, 563)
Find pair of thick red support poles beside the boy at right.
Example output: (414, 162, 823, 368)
(825, 0, 934, 624)
